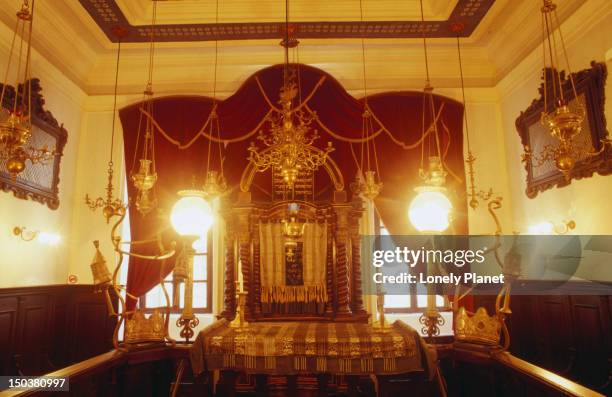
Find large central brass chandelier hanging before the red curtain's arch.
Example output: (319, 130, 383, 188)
(248, 0, 334, 190)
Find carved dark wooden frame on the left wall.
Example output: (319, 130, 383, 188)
(0, 78, 68, 210)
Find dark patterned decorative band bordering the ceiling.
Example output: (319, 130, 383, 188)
(79, 0, 495, 43)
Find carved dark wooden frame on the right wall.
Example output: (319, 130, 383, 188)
(515, 61, 612, 198)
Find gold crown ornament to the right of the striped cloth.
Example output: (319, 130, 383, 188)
(455, 307, 502, 345)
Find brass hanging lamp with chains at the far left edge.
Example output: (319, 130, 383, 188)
(0, 0, 56, 180)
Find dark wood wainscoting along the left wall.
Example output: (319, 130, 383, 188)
(0, 285, 116, 375)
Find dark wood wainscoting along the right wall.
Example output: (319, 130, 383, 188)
(474, 282, 612, 395)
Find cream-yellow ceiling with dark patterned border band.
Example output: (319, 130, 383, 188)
(0, 0, 592, 95)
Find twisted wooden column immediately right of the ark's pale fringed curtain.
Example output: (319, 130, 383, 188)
(334, 205, 352, 317)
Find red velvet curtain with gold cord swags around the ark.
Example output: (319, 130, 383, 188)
(120, 65, 467, 308)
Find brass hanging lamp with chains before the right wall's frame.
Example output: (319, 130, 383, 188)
(523, 0, 609, 180)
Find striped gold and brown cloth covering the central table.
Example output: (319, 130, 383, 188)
(191, 320, 436, 375)
